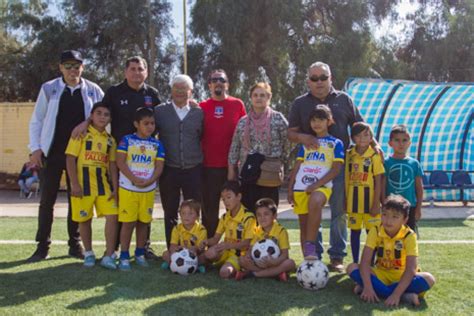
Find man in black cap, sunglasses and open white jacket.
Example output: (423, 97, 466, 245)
(27, 50, 104, 262)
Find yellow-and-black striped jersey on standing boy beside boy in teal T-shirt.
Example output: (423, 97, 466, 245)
(344, 146, 385, 213)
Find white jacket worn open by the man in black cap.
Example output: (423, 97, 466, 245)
(28, 77, 104, 156)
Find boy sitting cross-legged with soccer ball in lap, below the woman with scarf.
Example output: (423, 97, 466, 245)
(235, 198, 295, 282)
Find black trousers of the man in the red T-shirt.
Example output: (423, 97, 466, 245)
(202, 168, 227, 238)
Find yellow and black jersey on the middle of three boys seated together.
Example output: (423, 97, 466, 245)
(216, 205, 256, 256)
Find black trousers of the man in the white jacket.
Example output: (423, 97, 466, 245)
(36, 154, 81, 252)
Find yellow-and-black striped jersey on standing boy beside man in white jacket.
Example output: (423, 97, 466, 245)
(65, 125, 117, 196)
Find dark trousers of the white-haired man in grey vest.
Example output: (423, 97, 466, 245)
(159, 165, 202, 248)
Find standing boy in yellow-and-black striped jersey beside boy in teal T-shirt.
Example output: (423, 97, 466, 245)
(344, 122, 385, 263)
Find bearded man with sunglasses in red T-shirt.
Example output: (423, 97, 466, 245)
(199, 69, 246, 237)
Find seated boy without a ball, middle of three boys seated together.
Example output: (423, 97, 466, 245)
(205, 181, 255, 279)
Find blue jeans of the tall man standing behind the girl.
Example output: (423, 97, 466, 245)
(316, 170, 347, 260)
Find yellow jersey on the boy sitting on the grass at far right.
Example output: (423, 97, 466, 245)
(365, 225, 418, 275)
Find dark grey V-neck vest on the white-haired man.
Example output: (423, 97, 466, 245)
(155, 101, 204, 169)
